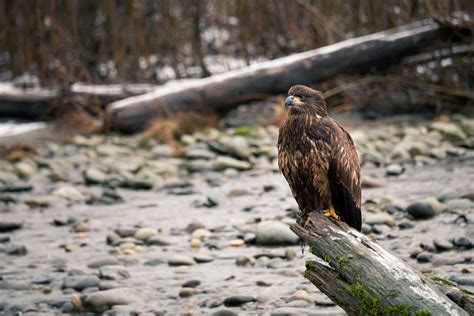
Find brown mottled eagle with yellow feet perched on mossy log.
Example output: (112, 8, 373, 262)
(278, 85, 362, 231)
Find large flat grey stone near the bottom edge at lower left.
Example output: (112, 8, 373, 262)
(81, 288, 141, 313)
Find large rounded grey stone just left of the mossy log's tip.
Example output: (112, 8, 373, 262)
(257, 221, 298, 246)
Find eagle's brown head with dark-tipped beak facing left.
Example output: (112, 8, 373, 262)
(285, 85, 328, 116)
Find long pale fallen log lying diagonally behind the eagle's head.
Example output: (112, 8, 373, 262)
(106, 20, 454, 132)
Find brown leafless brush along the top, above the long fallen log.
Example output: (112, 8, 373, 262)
(0, 0, 473, 85)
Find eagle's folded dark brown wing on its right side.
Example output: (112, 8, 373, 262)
(323, 117, 362, 231)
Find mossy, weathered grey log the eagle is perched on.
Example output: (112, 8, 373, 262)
(291, 212, 468, 315)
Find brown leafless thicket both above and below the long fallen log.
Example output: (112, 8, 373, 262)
(0, 0, 474, 127)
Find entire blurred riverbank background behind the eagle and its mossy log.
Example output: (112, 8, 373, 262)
(0, 0, 474, 315)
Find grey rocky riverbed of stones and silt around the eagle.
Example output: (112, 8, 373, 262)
(0, 115, 474, 315)
